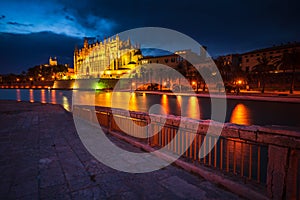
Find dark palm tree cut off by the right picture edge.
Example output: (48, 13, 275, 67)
(277, 49, 300, 94)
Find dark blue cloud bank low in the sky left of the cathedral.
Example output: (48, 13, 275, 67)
(0, 32, 82, 74)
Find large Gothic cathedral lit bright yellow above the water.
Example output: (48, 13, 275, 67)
(74, 35, 142, 79)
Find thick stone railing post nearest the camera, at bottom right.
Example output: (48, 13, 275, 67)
(267, 145, 288, 199)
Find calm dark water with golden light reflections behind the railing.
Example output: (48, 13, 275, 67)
(0, 89, 300, 127)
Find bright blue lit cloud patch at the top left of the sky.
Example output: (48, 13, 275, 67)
(0, 1, 116, 38)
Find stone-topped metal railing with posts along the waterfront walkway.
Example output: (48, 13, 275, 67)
(73, 106, 300, 199)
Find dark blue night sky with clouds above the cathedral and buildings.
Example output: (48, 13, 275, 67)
(0, 0, 300, 74)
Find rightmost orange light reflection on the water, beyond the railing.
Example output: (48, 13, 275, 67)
(230, 103, 251, 125)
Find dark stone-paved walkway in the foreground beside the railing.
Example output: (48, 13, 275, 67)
(0, 101, 239, 199)
